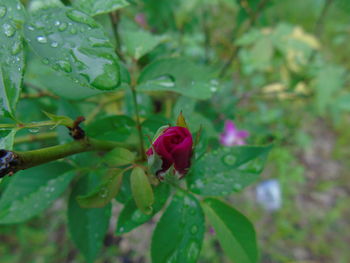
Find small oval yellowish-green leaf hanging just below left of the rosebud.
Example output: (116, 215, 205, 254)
(130, 167, 154, 215)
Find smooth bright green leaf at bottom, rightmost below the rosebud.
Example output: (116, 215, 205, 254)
(202, 198, 258, 263)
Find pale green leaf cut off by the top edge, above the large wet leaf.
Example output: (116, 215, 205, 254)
(73, 0, 129, 16)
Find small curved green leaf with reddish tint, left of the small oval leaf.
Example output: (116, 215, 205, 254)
(77, 169, 123, 208)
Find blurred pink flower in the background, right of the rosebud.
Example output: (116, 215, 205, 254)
(220, 120, 249, 146)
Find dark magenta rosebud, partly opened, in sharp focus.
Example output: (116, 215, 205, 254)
(146, 126, 193, 175)
